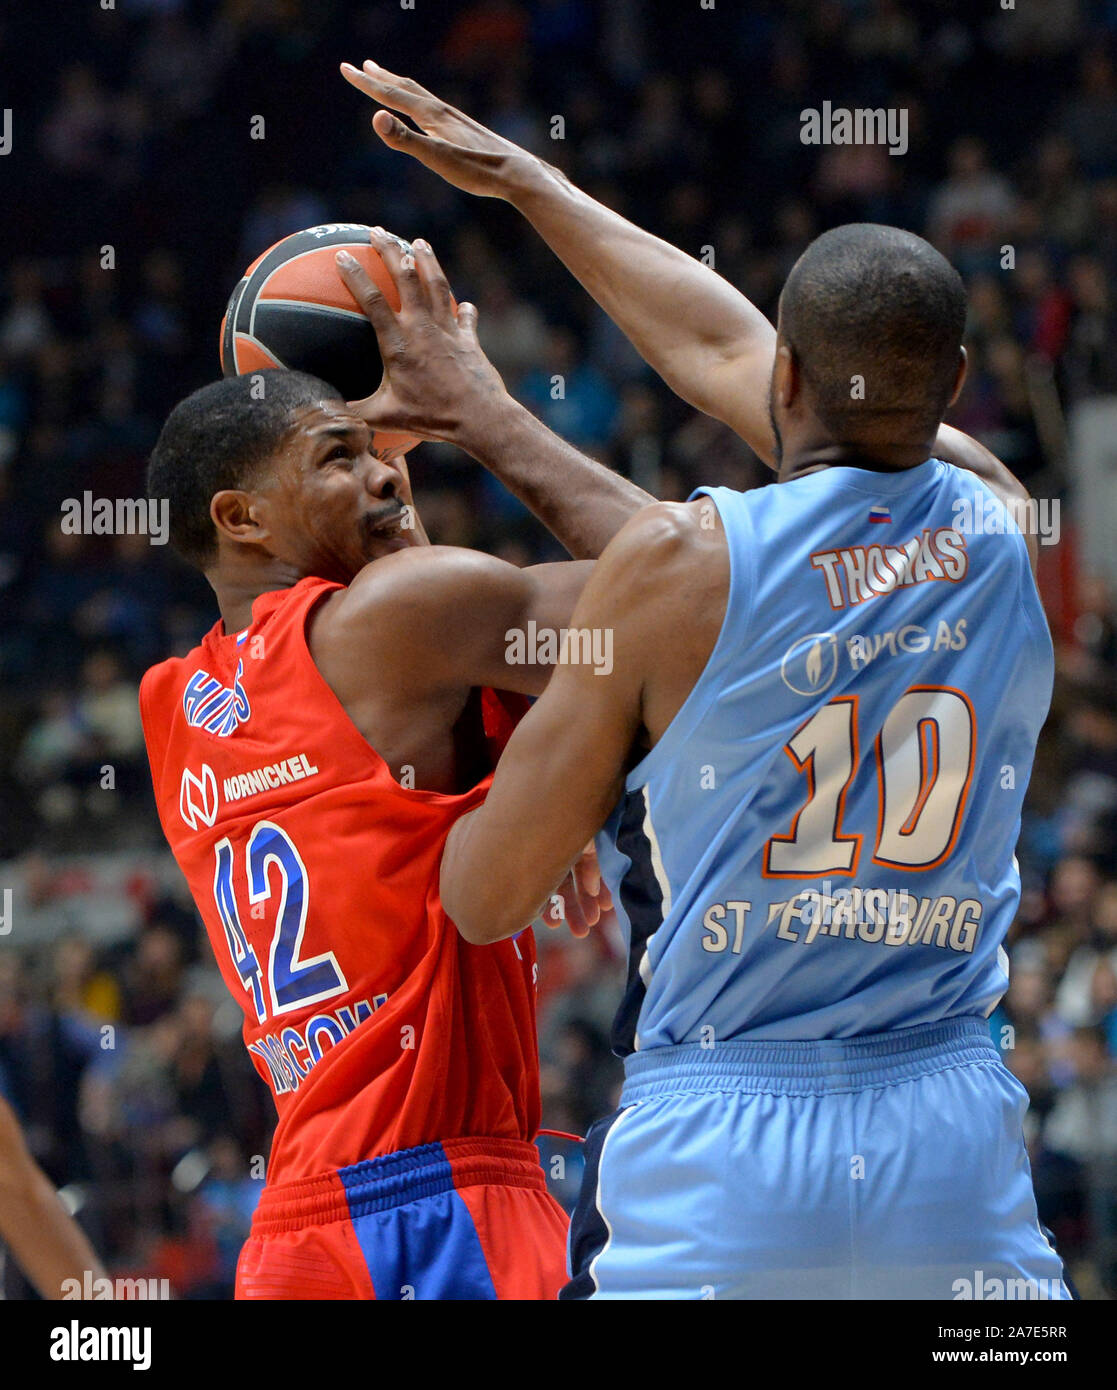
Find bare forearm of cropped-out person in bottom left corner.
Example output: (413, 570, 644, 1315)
(0, 1165, 104, 1298)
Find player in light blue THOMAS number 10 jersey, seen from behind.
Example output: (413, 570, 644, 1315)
(350, 68, 1070, 1298)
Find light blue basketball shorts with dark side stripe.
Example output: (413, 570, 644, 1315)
(560, 1017, 1071, 1300)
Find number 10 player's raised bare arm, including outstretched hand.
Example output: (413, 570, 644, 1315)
(342, 63, 775, 463)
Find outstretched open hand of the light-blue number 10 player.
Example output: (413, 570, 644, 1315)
(342, 60, 542, 197)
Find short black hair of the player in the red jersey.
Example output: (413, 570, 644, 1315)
(147, 368, 342, 569)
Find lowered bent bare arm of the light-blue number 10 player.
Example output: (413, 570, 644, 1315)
(442, 503, 728, 945)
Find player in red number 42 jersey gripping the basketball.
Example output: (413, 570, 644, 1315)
(140, 234, 652, 1298)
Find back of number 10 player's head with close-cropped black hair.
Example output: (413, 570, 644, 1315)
(781, 222, 966, 443)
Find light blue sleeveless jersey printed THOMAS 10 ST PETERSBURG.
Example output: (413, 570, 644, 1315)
(597, 459, 1053, 1054)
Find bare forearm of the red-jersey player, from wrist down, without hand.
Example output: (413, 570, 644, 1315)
(454, 399, 656, 560)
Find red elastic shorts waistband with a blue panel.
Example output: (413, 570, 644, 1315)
(251, 1138, 547, 1236)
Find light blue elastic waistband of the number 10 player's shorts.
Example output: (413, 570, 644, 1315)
(621, 1017, 1000, 1105)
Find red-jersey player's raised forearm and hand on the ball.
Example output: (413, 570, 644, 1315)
(338, 228, 654, 560)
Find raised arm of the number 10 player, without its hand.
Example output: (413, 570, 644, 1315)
(506, 160, 775, 457)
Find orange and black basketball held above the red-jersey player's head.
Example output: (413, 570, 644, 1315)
(221, 222, 417, 448)
